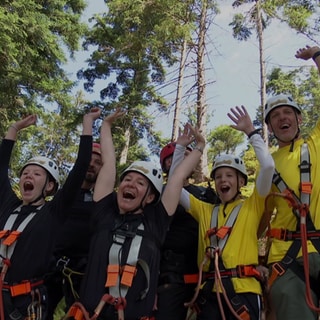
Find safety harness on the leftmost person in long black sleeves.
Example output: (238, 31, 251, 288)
(0, 205, 43, 320)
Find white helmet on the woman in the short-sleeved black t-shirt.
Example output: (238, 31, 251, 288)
(120, 161, 163, 196)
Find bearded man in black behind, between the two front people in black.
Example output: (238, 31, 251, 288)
(46, 143, 102, 318)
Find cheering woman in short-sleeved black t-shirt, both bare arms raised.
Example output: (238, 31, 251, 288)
(76, 110, 204, 320)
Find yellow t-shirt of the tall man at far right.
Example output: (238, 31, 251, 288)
(268, 121, 320, 263)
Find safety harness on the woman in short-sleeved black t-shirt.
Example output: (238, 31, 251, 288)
(67, 219, 150, 320)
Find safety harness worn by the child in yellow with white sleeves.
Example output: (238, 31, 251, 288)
(186, 203, 260, 320)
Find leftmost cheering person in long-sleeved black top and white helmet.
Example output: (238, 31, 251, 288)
(0, 109, 100, 320)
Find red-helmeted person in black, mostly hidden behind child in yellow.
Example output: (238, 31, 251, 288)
(155, 142, 218, 320)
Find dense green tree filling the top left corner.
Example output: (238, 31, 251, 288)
(0, 0, 85, 132)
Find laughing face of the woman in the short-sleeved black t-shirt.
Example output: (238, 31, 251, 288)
(117, 171, 155, 213)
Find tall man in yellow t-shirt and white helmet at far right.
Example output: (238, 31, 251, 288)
(265, 46, 320, 320)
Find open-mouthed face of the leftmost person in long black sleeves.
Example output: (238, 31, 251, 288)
(19, 164, 55, 205)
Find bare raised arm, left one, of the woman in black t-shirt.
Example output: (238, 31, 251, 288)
(93, 109, 125, 201)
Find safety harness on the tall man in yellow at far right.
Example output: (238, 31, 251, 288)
(267, 143, 320, 313)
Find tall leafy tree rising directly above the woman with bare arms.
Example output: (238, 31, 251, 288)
(78, 0, 194, 162)
